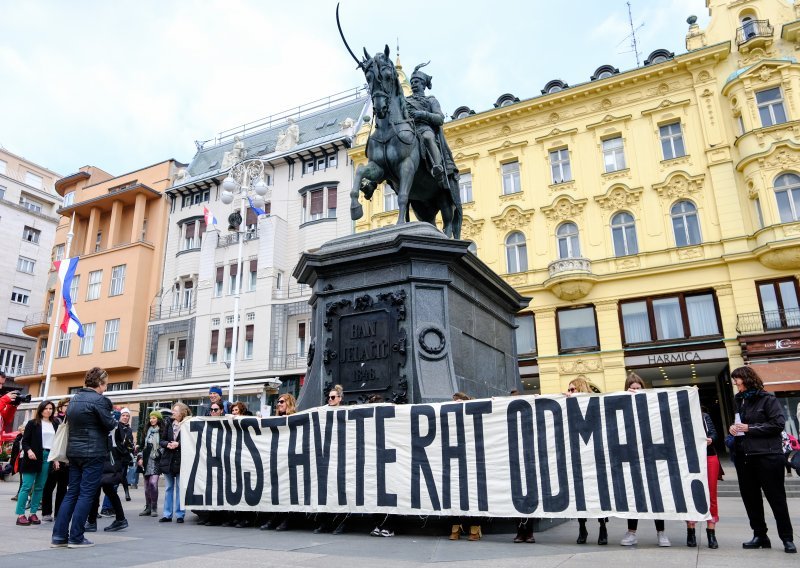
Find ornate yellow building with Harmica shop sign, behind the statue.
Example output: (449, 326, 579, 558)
(351, 0, 800, 432)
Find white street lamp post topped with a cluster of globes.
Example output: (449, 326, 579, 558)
(220, 158, 269, 402)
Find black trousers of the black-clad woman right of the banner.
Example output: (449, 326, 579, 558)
(736, 454, 794, 540)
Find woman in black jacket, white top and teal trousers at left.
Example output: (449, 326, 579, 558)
(16, 400, 58, 527)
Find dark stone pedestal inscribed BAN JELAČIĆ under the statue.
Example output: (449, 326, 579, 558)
(294, 223, 529, 409)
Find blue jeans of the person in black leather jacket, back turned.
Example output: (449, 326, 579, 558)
(53, 457, 105, 543)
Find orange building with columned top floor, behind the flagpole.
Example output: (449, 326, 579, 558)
(16, 160, 181, 400)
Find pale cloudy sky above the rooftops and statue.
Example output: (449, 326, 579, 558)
(0, 0, 708, 175)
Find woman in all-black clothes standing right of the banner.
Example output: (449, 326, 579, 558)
(729, 367, 797, 553)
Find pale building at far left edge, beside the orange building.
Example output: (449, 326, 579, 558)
(0, 147, 63, 377)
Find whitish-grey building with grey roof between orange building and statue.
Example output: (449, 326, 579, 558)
(141, 87, 369, 412)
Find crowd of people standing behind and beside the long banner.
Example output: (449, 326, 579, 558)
(3, 367, 797, 553)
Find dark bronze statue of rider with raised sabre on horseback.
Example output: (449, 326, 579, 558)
(336, 6, 462, 239)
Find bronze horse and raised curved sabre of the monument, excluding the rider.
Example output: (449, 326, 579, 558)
(336, 14, 462, 239)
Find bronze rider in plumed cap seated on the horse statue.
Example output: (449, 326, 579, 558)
(406, 63, 458, 188)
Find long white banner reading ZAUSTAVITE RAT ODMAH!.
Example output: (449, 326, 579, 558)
(181, 388, 710, 520)
